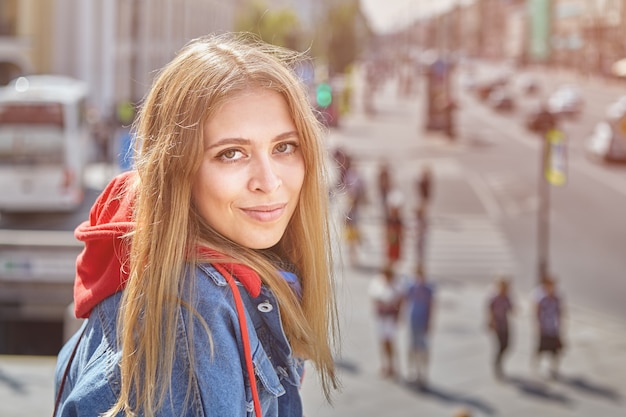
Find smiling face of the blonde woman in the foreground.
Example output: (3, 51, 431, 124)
(193, 88, 304, 249)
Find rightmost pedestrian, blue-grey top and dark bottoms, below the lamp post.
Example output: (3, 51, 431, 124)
(536, 277, 564, 378)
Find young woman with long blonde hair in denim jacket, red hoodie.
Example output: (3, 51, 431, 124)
(55, 35, 338, 417)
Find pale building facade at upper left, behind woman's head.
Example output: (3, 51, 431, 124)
(0, 0, 238, 117)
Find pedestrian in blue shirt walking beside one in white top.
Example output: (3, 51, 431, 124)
(405, 264, 434, 387)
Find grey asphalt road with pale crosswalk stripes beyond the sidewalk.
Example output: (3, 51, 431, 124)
(329, 61, 626, 322)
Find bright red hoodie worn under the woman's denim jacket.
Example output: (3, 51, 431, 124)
(74, 171, 261, 318)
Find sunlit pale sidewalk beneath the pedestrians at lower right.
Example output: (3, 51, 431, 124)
(303, 260, 626, 417)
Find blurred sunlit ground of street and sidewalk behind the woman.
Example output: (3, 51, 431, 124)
(0, 62, 626, 417)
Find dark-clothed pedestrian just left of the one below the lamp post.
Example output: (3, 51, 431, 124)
(487, 276, 513, 379)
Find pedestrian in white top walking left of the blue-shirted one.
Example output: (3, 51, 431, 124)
(368, 266, 404, 377)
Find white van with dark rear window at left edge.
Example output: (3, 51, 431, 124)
(0, 75, 90, 212)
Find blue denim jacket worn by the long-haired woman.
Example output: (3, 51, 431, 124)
(55, 265, 304, 417)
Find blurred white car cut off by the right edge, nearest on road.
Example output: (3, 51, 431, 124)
(585, 97, 626, 162)
